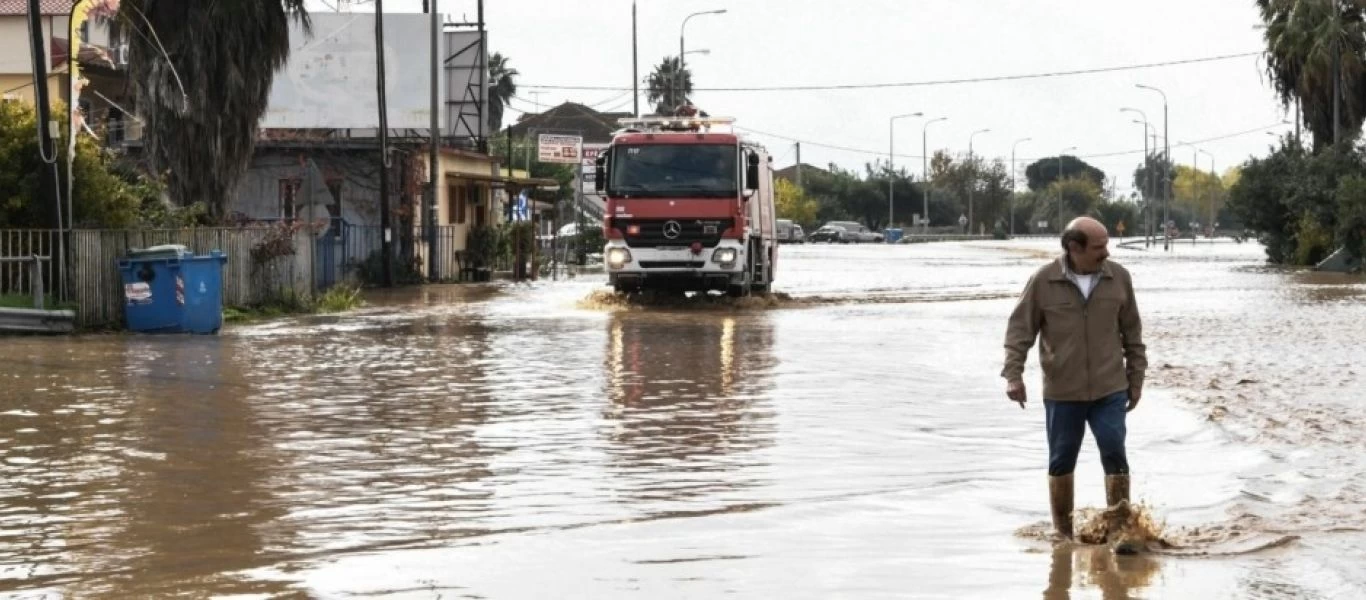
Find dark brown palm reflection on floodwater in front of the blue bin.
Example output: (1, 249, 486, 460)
(108, 338, 288, 597)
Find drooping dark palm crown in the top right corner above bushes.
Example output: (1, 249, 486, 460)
(1257, 0, 1366, 152)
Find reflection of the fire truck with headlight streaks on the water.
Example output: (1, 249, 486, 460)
(602, 313, 775, 502)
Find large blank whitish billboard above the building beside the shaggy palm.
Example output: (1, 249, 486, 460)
(261, 12, 445, 130)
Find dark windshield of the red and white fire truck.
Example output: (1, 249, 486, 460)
(611, 144, 739, 198)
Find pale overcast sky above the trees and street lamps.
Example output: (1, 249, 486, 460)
(310, 0, 1294, 194)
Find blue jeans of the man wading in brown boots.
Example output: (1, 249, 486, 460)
(1044, 391, 1128, 476)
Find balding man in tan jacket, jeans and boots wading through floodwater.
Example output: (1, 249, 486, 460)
(1001, 217, 1147, 538)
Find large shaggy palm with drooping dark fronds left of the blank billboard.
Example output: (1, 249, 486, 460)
(119, 0, 311, 219)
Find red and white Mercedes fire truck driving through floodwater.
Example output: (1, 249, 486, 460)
(594, 116, 777, 295)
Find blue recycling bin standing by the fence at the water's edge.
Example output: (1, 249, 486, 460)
(119, 245, 228, 333)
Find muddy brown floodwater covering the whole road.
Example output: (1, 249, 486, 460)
(0, 241, 1366, 599)
